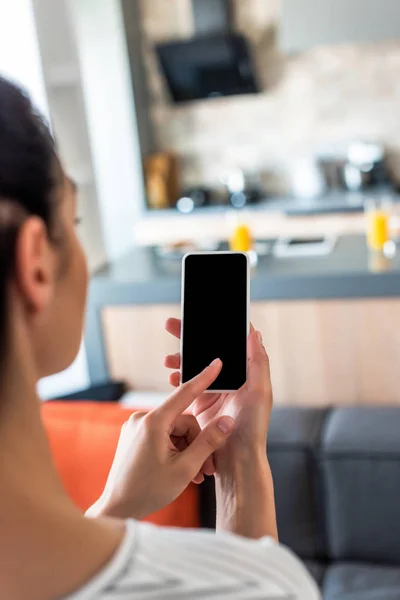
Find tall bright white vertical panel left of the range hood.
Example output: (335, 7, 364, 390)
(69, 0, 145, 260)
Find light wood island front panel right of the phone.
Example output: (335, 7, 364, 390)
(252, 299, 400, 406)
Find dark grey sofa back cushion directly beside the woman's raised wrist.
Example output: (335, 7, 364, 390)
(267, 407, 326, 559)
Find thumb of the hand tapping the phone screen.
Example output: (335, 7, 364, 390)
(180, 417, 235, 479)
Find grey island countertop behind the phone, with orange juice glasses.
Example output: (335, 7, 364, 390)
(91, 236, 400, 304)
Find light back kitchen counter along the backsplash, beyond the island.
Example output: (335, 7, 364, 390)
(133, 189, 400, 246)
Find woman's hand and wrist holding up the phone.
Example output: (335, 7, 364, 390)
(165, 319, 278, 539)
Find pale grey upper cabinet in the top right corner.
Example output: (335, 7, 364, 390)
(279, 0, 400, 53)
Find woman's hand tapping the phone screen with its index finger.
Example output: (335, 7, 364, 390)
(87, 360, 234, 519)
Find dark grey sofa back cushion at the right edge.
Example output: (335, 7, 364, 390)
(321, 407, 400, 564)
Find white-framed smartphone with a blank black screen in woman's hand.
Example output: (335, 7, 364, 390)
(181, 252, 250, 392)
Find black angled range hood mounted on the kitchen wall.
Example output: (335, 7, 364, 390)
(156, 0, 259, 103)
